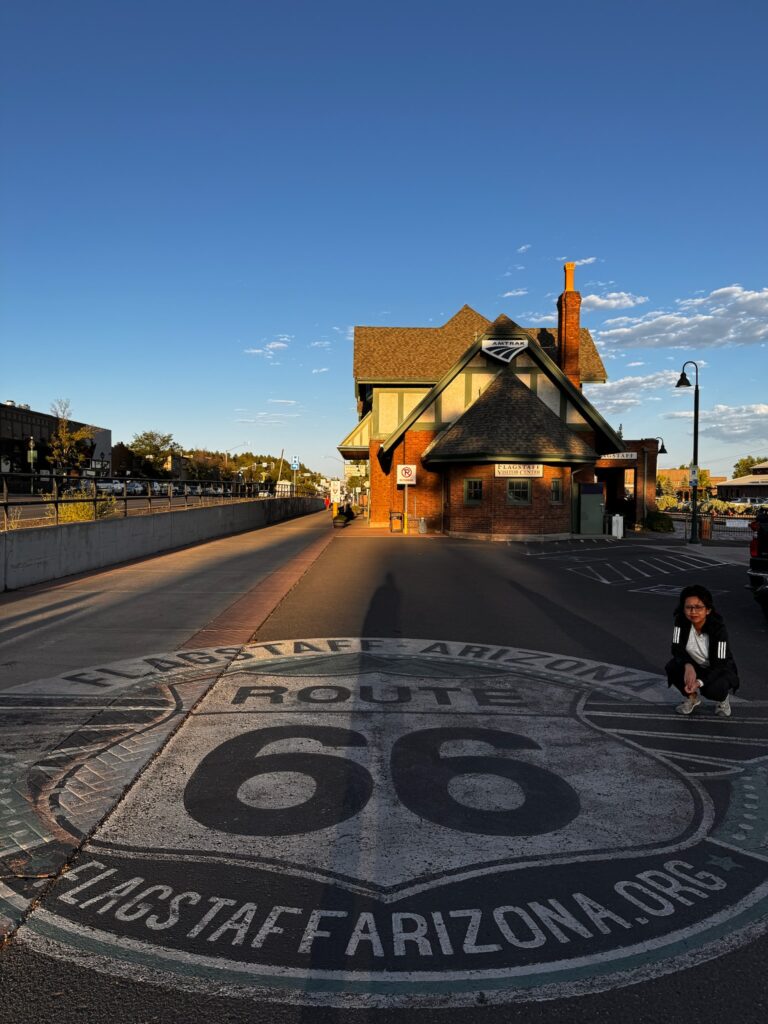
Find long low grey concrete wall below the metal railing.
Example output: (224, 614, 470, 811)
(0, 498, 325, 590)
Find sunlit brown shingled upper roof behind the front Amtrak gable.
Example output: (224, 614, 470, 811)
(353, 305, 608, 384)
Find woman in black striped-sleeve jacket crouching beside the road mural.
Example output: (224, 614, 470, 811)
(666, 584, 739, 718)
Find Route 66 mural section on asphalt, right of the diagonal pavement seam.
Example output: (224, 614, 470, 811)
(6, 638, 768, 1007)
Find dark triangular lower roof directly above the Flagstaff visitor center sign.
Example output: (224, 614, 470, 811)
(422, 366, 597, 466)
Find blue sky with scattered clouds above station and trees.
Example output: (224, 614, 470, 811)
(0, 0, 768, 475)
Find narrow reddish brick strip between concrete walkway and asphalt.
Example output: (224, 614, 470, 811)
(178, 532, 334, 650)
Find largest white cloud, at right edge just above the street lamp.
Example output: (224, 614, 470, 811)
(596, 285, 768, 350)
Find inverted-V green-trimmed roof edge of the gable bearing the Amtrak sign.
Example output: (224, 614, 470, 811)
(380, 314, 625, 458)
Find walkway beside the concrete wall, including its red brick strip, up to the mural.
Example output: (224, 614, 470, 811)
(0, 512, 338, 690)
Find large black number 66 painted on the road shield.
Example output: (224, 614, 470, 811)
(184, 725, 580, 836)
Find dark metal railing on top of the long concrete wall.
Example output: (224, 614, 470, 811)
(0, 473, 314, 530)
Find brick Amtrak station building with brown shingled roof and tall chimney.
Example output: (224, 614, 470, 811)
(338, 263, 658, 540)
